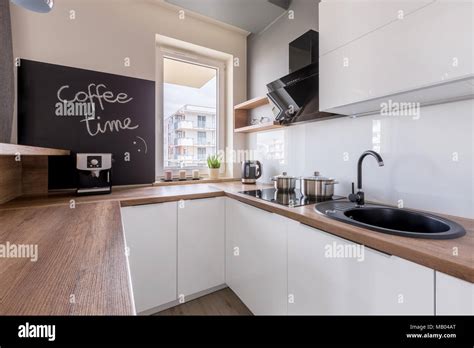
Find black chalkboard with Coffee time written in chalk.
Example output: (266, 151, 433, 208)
(18, 59, 155, 189)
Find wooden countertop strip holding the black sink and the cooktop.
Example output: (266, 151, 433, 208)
(214, 183, 474, 283)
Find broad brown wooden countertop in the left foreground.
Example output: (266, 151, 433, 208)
(0, 202, 135, 315)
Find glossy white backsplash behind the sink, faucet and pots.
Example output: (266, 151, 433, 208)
(248, 100, 474, 218)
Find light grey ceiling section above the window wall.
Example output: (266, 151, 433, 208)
(165, 0, 290, 34)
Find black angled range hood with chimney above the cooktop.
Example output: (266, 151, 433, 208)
(267, 30, 342, 124)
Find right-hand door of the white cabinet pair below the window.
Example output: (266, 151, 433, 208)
(178, 197, 225, 296)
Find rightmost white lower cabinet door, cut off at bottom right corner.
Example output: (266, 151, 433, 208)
(436, 272, 474, 315)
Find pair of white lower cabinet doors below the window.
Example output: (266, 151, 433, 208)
(122, 197, 225, 314)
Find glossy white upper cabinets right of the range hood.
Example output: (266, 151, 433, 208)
(319, 1, 474, 115)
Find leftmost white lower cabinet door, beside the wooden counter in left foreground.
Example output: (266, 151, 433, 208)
(122, 202, 177, 313)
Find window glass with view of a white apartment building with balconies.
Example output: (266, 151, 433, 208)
(158, 53, 223, 172)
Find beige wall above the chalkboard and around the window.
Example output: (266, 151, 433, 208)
(11, 0, 247, 178)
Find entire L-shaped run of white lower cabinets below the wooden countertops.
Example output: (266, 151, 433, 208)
(122, 197, 466, 315)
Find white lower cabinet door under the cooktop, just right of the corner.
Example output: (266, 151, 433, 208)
(226, 199, 288, 315)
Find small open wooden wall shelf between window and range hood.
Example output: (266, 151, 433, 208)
(234, 97, 282, 133)
